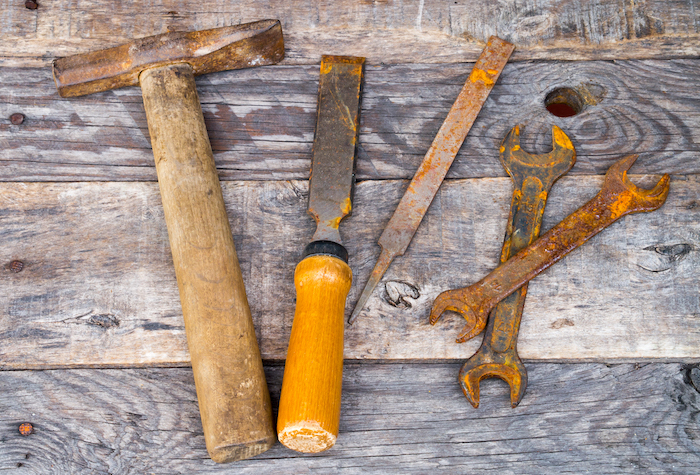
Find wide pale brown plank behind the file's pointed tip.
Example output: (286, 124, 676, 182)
(0, 176, 700, 369)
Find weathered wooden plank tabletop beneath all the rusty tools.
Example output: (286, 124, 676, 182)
(0, 0, 700, 474)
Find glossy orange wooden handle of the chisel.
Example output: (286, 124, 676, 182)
(277, 254, 352, 453)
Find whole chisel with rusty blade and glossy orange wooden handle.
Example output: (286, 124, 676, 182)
(277, 56, 365, 452)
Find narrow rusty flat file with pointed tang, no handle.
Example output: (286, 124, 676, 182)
(348, 36, 515, 324)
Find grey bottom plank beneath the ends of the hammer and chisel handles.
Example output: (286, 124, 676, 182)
(0, 364, 700, 475)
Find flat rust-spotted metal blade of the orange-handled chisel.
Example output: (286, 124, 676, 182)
(308, 56, 365, 245)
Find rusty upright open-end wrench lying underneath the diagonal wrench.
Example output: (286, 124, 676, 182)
(459, 126, 576, 407)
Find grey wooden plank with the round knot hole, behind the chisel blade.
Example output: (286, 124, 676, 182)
(0, 60, 700, 181)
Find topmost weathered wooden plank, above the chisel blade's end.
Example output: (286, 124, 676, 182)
(0, 0, 700, 67)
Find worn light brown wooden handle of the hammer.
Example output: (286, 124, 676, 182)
(140, 63, 275, 462)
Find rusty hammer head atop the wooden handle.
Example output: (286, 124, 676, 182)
(53, 20, 284, 97)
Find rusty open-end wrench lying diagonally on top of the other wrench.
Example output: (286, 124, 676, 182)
(430, 155, 671, 343)
